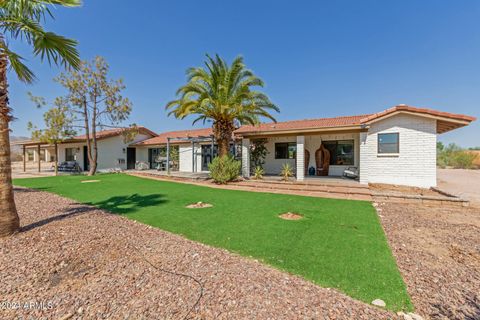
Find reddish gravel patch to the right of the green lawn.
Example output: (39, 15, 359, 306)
(377, 203, 480, 320)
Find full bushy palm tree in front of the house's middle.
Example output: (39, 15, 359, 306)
(166, 55, 279, 156)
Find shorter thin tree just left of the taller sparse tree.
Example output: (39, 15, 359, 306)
(28, 93, 76, 175)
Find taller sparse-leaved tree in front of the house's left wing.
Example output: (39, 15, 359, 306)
(55, 57, 136, 175)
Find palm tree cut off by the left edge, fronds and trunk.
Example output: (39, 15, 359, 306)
(0, 0, 80, 237)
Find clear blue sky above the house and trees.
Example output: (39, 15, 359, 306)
(10, 0, 480, 146)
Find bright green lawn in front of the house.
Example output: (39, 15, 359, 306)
(15, 174, 412, 311)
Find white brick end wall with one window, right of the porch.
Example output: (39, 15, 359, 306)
(360, 114, 437, 188)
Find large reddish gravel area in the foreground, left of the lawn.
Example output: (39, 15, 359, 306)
(0, 189, 396, 319)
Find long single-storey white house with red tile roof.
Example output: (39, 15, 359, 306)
(15, 105, 475, 187)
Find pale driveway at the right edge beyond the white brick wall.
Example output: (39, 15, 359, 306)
(437, 169, 480, 204)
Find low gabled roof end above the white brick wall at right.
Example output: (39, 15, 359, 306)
(361, 104, 476, 133)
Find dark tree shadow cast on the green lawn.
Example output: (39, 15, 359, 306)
(88, 193, 167, 214)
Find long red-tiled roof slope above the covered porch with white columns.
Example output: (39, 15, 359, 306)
(235, 114, 370, 135)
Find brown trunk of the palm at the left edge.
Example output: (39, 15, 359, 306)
(0, 50, 20, 237)
